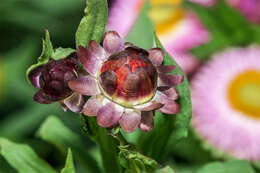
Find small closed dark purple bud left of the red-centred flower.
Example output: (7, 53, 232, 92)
(29, 53, 84, 112)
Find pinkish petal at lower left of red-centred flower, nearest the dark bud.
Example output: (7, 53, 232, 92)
(82, 95, 103, 116)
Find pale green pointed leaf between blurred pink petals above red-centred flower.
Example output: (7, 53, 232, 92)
(125, 1, 154, 49)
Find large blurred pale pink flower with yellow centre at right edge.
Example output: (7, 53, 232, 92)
(191, 46, 260, 160)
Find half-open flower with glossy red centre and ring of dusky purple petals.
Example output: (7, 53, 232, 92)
(69, 31, 183, 132)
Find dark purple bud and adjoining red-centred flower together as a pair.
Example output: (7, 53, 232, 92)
(29, 31, 183, 132)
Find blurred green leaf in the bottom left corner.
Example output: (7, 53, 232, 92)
(0, 138, 56, 173)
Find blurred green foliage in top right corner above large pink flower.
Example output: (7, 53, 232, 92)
(185, 0, 260, 61)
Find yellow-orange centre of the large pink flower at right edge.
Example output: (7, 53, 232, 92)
(228, 70, 260, 118)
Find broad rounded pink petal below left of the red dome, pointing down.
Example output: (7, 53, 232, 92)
(97, 102, 124, 128)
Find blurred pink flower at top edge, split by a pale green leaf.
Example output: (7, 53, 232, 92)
(107, 0, 209, 73)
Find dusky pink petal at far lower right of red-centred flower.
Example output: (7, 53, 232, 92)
(159, 94, 180, 114)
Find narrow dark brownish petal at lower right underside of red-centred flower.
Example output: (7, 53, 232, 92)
(139, 111, 154, 132)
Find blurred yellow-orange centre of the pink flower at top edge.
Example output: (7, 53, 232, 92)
(149, 0, 184, 34)
